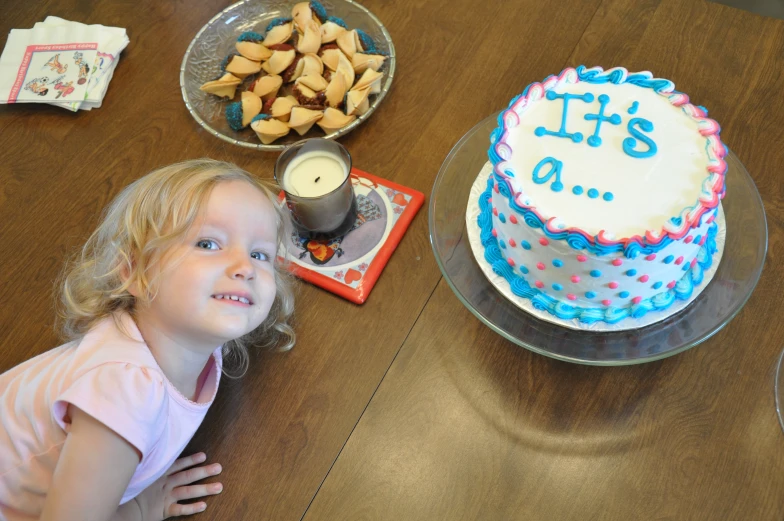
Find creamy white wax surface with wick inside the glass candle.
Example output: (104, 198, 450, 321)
(282, 150, 348, 197)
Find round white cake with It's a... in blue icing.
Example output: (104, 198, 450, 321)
(478, 66, 727, 324)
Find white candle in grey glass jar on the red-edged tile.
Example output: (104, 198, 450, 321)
(275, 138, 357, 240)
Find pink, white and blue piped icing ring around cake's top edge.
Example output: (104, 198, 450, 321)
(487, 65, 728, 258)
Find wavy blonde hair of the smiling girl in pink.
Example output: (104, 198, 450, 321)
(58, 159, 295, 376)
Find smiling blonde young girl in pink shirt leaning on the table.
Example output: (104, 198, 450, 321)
(0, 160, 294, 521)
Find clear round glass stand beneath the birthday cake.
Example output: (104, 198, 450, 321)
(429, 113, 768, 365)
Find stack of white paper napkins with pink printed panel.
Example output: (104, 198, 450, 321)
(0, 16, 129, 111)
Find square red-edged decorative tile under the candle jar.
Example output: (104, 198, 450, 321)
(278, 168, 425, 304)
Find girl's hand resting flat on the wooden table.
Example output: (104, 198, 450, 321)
(136, 452, 223, 521)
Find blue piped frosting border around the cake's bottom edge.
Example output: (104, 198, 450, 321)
(477, 177, 719, 324)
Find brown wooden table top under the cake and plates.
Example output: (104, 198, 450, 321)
(0, 0, 784, 521)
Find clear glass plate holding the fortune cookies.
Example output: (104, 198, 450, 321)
(180, 0, 395, 151)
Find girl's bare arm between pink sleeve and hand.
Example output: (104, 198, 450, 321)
(41, 405, 142, 521)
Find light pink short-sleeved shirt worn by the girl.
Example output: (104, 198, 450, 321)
(0, 314, 222, 521)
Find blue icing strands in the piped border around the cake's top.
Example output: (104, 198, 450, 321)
(487, 65, 727, 259)
